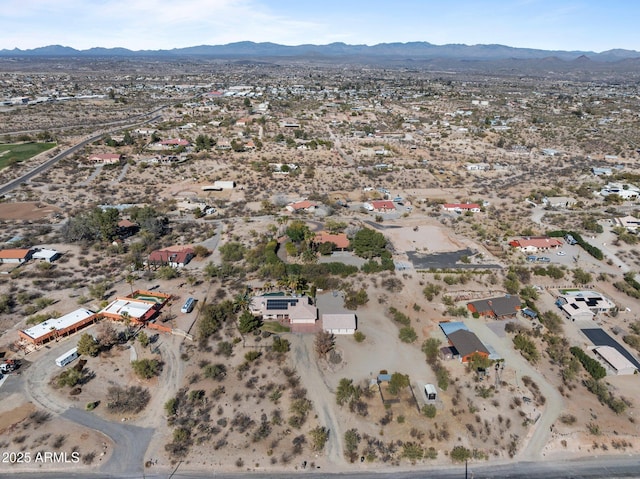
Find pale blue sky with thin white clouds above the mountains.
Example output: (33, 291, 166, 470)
(0, 0, 640, 52)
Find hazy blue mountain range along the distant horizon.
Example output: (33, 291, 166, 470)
(0, 41, 640, 63)
